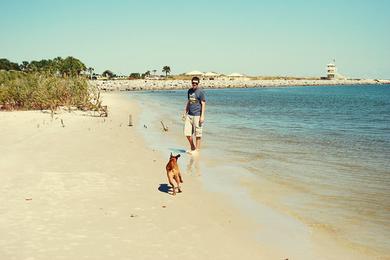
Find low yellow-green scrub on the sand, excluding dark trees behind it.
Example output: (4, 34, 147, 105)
(0, 71, 100, 110)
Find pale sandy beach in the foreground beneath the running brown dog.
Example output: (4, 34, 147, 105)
(0, 93, 384, 260)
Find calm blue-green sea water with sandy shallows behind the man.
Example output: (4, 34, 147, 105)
(128, 85, 390, 255)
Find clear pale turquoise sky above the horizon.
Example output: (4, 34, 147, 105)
(0, 0, 390, 79)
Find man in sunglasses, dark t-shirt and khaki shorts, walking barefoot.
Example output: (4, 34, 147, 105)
(184, 77, 206, 154)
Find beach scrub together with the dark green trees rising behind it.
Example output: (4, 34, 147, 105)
(0, 57, 102, 111)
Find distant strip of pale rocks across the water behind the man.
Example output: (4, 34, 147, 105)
(89, 79, 390, 91)
